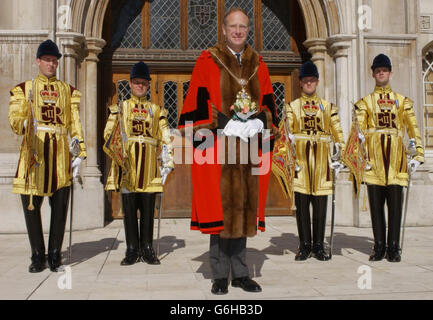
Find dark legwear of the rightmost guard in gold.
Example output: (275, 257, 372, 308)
(367, 185, 403, 247)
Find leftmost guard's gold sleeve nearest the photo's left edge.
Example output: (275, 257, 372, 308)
(8, 87, 28, 135)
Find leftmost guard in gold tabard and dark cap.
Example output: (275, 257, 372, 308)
(9, 40, 86, 273)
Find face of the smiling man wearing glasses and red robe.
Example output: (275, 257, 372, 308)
(223, 11, 249, 52)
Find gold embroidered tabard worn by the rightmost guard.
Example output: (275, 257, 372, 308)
(355, 86, 424, 186)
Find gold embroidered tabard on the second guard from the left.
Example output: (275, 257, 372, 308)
(104, 96, 174, 192)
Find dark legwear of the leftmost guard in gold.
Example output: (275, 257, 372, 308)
(21, 187, 70, 255)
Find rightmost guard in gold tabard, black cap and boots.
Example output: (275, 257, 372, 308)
(355, 54, 424, 262)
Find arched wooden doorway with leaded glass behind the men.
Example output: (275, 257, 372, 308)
(98, 0, 305, 218)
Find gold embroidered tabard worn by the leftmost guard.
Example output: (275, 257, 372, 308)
(9, 75, 86, 196)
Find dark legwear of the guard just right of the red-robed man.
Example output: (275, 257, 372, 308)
(295, 192, 328, 245)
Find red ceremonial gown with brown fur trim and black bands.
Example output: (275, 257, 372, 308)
(179, 45, 277, 238)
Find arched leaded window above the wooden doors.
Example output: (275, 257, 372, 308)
(111, 0, 291, 51)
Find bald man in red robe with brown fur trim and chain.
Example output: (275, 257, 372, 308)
(179, 8, 276, 294)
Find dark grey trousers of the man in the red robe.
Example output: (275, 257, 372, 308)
(209, 234, 249, 279)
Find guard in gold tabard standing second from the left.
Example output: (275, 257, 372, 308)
(104, 62, 174, 265)
